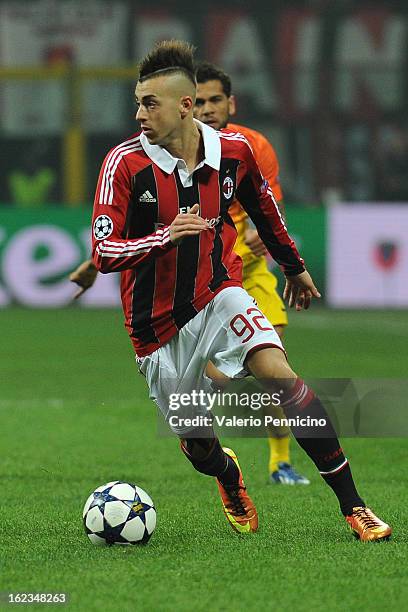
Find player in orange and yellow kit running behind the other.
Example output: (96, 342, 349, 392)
(194, 62, 309, 485)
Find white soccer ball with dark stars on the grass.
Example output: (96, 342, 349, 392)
(82, 480, 156, 545)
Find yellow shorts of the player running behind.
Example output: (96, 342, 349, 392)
(242, 258, 288, 325)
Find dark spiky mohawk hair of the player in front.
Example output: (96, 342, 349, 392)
(139, 40, 197, 85)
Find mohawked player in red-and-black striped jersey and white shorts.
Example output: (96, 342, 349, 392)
(92, 41, 391, 540)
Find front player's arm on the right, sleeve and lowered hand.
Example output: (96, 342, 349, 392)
(236, 144, 320, 310)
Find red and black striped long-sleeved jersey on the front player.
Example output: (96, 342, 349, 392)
(92, 122, 304, 357)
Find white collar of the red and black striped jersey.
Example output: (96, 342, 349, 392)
(140, 119, 221, 174)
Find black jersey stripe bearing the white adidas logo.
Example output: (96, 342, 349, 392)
(126, 165, 158, 344)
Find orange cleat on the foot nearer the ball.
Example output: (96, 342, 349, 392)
(217, 448, 258, 533)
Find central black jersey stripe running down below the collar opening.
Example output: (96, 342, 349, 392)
(172, 169, 200, 329)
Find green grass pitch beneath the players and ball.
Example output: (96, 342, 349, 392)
(0, 308, 408, 611)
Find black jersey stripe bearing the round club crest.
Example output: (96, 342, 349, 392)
(208, 157, 239, 291)
